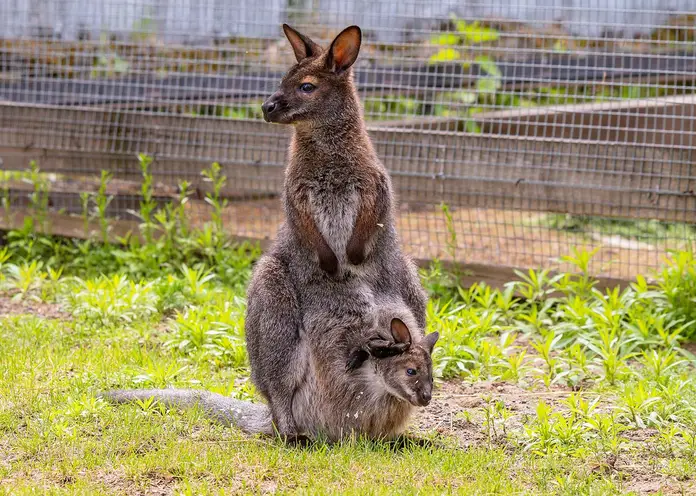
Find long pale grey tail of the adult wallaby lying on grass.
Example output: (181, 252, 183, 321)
(98, 389, 274, 435)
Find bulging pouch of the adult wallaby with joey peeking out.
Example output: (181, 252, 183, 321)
(293, 303, 439, 440)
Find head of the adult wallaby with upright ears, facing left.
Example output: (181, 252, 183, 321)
(261, 24, 362, 124)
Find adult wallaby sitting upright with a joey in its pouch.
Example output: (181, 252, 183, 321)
(102, 26, 437, 438)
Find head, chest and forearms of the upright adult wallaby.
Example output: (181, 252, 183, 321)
(264, 26, 392, 274)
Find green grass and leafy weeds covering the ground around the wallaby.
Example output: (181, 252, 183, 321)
(0, 159, 696, 495)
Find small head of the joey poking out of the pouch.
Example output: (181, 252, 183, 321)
(374, 319, 440, 406)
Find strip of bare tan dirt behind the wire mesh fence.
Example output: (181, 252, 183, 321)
(185, 199, 689, 279)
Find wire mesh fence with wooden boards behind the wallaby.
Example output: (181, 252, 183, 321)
(0, 0, 696, 279)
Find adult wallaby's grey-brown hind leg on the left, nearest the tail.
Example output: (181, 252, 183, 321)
(245, 255, 308, 435)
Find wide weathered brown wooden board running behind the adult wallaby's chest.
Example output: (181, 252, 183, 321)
(0, 103, 696, 223)
